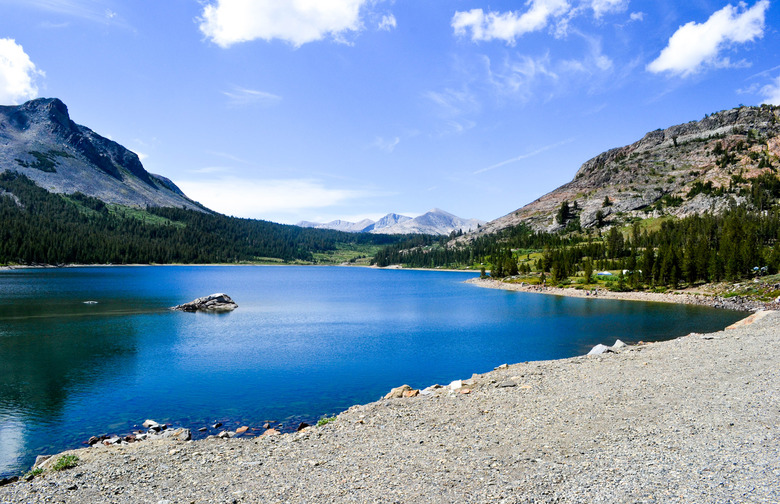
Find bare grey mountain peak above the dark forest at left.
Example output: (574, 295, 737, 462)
(0, 98, 201, 211)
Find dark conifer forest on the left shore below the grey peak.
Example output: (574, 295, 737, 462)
(0, 171, 398, 265)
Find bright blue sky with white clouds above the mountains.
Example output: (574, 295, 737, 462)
(0, 0, 780, 223)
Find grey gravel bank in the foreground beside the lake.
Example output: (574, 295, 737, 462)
(0, 312, 780, 504)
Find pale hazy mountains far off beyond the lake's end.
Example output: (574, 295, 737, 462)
(298, 208, 485, 235)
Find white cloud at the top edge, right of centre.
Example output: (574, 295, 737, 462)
(451, 0, 571, 44)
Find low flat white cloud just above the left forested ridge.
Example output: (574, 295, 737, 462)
(176, 177, 371, 222)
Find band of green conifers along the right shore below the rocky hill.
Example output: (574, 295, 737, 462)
(374, 207, 780, 288)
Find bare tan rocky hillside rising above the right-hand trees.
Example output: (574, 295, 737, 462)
(462, 105, 780, 240)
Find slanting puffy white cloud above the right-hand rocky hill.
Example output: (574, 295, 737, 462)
(647, 0, 769, 77)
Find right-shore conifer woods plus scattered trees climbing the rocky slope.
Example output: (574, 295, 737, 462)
(374, 133, 780, 289)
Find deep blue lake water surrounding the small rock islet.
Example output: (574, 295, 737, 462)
(0, 266, 744, 477)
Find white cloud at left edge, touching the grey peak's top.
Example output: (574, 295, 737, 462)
(0, 39, 45, 105)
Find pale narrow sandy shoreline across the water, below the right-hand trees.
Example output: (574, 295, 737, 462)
(465, 278, 780, 312)
